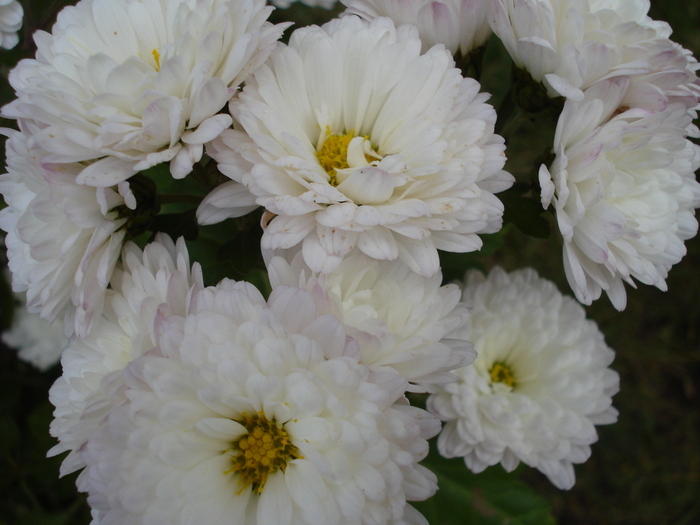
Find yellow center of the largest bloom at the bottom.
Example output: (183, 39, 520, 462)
(226, 414, 302, 494)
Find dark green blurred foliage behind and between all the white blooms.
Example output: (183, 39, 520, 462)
(0, 0, 700, 525)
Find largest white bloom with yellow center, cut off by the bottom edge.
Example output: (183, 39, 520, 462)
(83, 280, 439, 525)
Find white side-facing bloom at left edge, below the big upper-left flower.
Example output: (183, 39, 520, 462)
(0, 130, 133, 337)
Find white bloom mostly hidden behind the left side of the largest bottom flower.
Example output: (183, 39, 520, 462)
(49, 234, 204, 484)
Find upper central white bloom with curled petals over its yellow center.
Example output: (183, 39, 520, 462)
(205, 16, 512, 276)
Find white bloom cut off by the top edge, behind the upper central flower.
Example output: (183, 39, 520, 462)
(341, 0, 491, 56)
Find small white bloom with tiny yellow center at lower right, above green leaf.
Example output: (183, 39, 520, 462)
(428, 268, 619, 489)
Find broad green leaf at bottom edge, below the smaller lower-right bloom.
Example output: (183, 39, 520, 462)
(413, 443, 556, 525)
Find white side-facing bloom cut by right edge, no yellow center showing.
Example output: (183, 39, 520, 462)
(540, 78, 700, 310)
